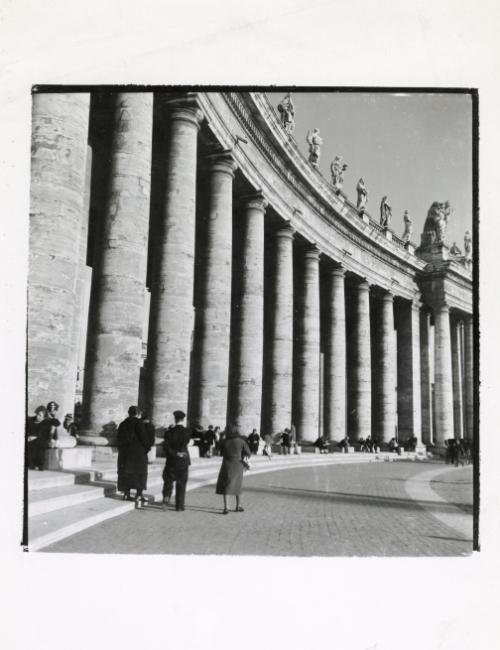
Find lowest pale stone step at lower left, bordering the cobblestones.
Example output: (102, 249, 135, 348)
(28, 498, 135, 551)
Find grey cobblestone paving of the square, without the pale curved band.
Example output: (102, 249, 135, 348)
(45, 462, 472, 556)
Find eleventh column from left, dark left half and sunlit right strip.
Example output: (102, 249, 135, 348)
(397, 301, 422, 445)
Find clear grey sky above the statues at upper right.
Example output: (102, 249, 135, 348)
(266, 92, 472, 250)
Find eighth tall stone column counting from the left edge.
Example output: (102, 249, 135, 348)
(324, 268, 346, 440)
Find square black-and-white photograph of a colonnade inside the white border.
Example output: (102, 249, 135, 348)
(25, 87, 478, 556)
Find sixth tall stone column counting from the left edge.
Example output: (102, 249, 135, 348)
(262, 225, 294, 434)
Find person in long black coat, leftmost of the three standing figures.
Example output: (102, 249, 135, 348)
(117, 406, 151, 508)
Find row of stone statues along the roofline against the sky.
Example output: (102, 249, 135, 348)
(278, 93, 472, 259)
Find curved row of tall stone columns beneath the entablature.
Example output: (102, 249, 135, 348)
(28, 93, 473, 446)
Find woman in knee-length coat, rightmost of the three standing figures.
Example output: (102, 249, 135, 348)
(215, 430, 250, 515)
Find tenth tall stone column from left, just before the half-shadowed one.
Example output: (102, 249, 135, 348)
(373, 292, 396, 443)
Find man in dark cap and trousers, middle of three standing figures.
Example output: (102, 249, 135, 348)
(163, 411, 191, 512)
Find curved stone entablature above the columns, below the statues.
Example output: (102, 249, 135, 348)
(198, 93, 426, 299)
